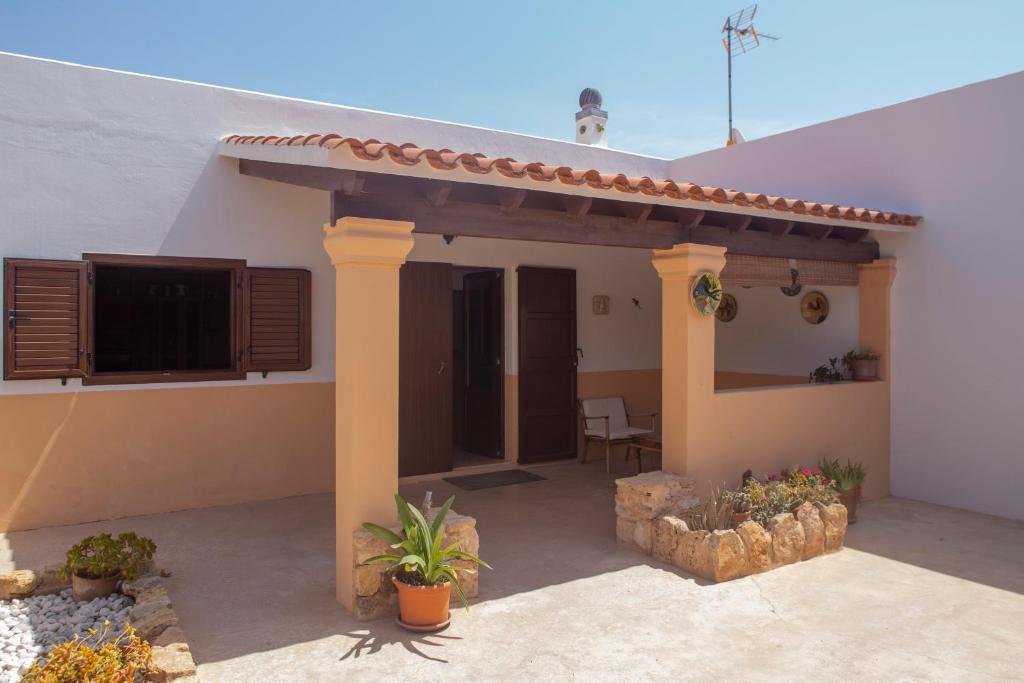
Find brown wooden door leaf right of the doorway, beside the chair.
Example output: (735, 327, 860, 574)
(518, 266, 577, 463)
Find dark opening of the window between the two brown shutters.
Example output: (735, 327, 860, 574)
(94, 265, 231, 373)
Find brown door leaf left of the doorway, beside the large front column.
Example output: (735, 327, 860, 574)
(398, 262, 452, 476)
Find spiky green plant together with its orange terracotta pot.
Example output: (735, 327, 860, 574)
(362, 495, 490, 632)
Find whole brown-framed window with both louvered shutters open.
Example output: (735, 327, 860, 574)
(4, 254, 311, 384)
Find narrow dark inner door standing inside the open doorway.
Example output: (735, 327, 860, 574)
(463, 270, 505, 458)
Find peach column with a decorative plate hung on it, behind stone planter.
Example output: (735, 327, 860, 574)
(652, 244, 725, 474)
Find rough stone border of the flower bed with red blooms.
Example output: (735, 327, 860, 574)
(615, 472, 847, 582)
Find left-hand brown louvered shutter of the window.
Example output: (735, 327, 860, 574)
(3, 258, 89, 380)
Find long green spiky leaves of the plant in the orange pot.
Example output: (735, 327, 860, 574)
(362, 494, 490, 608)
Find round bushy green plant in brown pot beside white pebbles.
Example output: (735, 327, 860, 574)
(60, 531, 157, 602)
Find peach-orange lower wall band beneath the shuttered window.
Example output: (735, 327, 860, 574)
(0, 383, 334, 531)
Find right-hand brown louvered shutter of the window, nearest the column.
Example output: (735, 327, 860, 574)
(242, 268, 312, 372)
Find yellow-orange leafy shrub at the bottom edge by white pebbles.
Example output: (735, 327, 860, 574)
(22, 622, 153, 683)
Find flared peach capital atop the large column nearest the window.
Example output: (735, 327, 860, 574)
(324, 216, 415, 268)
